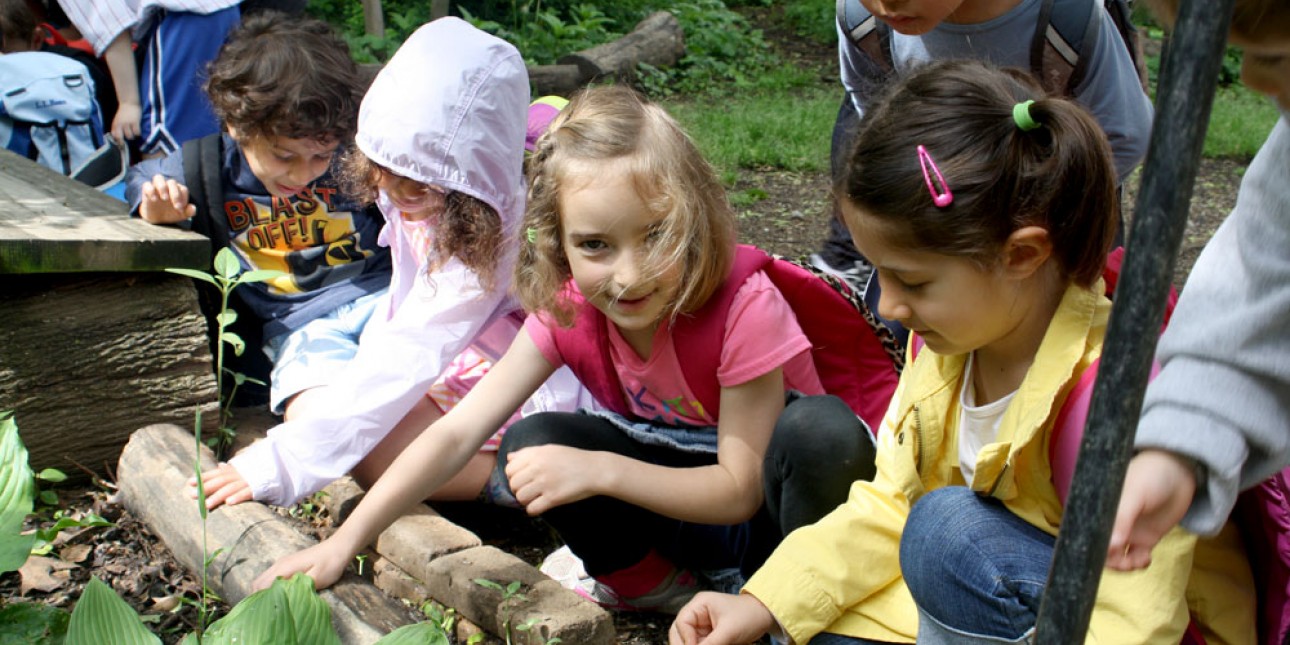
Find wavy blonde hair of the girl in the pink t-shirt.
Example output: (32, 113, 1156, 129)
(515, 85, 735, 325)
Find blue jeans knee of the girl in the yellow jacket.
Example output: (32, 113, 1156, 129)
(900, 486, 1057, 644)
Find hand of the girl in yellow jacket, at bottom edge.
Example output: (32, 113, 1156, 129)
(667, 591, 777, 645)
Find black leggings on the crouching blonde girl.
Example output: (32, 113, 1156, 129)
(497, 396, 873, 575)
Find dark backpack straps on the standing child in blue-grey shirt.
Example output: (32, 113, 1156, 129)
(837, 0, 1147, 97)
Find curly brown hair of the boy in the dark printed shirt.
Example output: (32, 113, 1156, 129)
(205, 12, 362, 144)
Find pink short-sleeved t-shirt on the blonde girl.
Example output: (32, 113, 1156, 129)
(524, 271, 824, 426)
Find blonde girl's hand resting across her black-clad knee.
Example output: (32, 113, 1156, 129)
(506, 445, 611, 515)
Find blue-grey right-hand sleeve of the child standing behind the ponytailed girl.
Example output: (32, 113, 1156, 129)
(1075, 4, 1153, 182)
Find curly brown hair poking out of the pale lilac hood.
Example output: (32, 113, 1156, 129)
(339, 147, 503, 292)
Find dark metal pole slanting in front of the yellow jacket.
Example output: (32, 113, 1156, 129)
(1036, 0, 1233, 645)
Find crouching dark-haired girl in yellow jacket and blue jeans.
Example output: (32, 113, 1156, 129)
(671, 61, 1254, 645)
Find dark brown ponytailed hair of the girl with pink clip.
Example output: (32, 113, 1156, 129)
(835, 61, 1120, 286)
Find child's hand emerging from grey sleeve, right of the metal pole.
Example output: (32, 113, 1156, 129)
(1107, 450, 1196, 571)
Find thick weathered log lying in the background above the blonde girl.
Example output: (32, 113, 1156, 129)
(556, 12, 685, 83)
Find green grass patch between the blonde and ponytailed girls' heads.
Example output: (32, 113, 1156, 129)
(662, 88, 840, 176)
